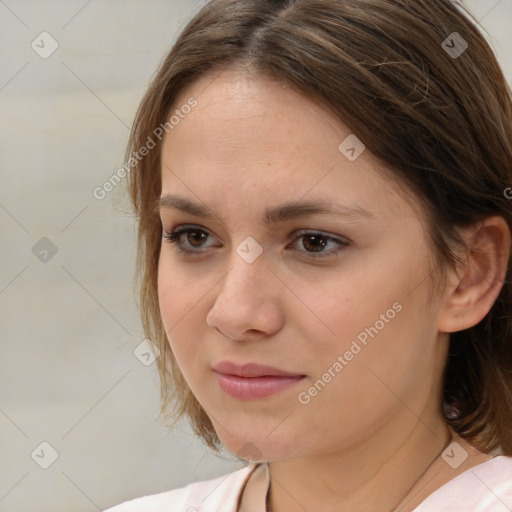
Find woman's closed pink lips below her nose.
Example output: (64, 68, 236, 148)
(213, 361, 305, 400)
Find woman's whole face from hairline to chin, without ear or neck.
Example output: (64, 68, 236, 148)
(158, 71, 446, 460)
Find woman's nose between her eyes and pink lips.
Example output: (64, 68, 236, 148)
(206, 250, 284, 341)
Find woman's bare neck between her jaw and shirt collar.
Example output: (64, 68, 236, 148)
(269, 411, 451, 512)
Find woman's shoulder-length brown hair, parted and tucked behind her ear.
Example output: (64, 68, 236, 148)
(127, 0, 512, 455)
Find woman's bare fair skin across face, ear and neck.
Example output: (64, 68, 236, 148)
(158, 69, 510, 512)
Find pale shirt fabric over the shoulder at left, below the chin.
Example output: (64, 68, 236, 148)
(104, 464, 254, 512)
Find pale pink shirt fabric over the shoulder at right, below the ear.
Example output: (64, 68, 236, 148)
(413, 455, 512, 512)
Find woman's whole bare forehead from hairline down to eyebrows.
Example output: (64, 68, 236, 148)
(161, 70, 416, 226)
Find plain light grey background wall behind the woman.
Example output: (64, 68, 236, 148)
(0, 0, 512, 512)
